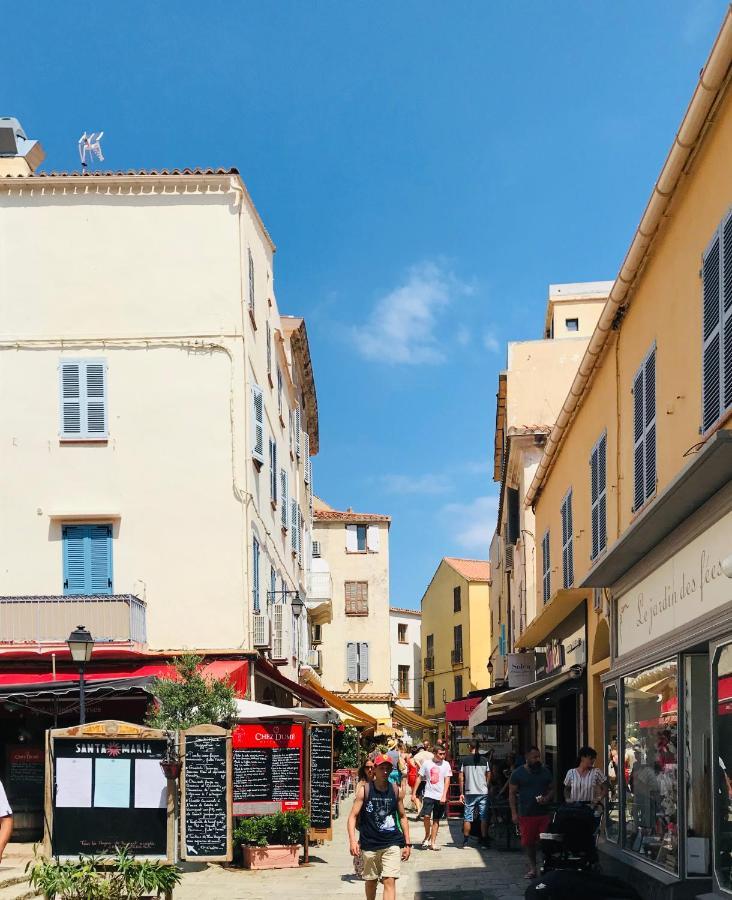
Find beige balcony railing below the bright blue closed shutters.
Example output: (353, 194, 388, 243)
(0, 594, 147, 644)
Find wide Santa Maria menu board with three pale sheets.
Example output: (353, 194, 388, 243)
(50, 723, 169, 857)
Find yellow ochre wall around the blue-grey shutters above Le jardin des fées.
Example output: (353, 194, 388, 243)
(536, 79, 732, 742)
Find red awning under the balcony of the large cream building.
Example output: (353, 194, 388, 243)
(0, 659, 249, 697)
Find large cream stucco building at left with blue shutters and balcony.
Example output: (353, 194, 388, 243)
(0, 120, 323, 674)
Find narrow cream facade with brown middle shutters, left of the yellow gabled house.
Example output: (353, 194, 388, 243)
(312, 497, 396, 722)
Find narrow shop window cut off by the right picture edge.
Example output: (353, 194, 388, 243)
(712, 644, 732, 891)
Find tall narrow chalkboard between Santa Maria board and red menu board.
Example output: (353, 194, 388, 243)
(181, 725, 232, 862)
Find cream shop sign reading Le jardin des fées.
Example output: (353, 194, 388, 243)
(616, 513, 732, 656)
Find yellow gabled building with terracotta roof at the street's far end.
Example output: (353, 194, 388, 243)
(421, 556, 491, 735)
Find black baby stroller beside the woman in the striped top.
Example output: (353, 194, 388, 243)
(540, 803, 600, 873)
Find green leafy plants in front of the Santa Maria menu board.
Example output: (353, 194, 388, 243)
(26, 847, 181, 900)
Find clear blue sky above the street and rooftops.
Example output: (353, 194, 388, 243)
(0, 0, 726, 606)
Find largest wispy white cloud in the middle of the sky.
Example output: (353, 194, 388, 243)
(351, 262, 472, 365)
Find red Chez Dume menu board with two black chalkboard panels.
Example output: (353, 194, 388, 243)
(232, 722, 304, 816)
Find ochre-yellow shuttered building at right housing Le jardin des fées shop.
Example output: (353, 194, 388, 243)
(518, 11, 732, 896)
